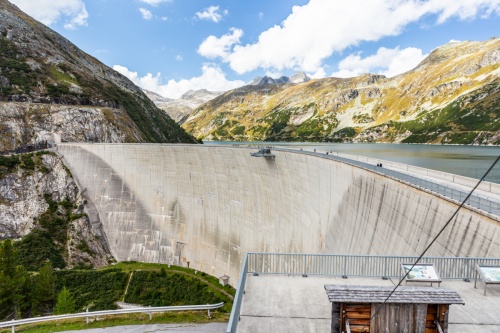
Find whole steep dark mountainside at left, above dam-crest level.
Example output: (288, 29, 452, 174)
(0, 0, 195, 150)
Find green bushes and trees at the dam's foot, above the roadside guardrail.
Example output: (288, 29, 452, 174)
(0, 240, 234, 321)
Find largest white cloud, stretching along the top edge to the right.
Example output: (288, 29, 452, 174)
(204, 0, 500, 74)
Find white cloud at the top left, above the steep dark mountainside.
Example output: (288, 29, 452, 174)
(10, 0, 89, 29)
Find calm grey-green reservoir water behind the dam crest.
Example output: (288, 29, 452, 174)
(205, 141, 500, 183)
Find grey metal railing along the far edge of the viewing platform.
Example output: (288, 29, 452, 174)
(247, 253, 500, 279)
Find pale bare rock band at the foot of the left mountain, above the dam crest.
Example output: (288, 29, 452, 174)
(0, 102, 142, 150)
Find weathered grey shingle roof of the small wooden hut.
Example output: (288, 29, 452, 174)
(325, 284, 465, 304)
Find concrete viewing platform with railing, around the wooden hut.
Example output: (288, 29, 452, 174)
(227, 253, 500, 333)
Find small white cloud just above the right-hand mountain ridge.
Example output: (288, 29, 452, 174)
(332, 47, 427, 77)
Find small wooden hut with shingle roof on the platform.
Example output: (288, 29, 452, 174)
(325, 285, 465, 333)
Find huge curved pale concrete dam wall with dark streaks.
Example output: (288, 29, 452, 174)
(57, 144, 500, 285)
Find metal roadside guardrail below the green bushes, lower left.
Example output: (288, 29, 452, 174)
(0, 302, 224, 333)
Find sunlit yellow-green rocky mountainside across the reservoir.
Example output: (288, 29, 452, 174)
(183, 38, 500, 144)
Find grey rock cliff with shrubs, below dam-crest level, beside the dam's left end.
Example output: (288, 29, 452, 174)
(0, 152, 112, 268)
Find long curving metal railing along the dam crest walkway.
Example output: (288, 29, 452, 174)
(273, 148, 500, 216)
